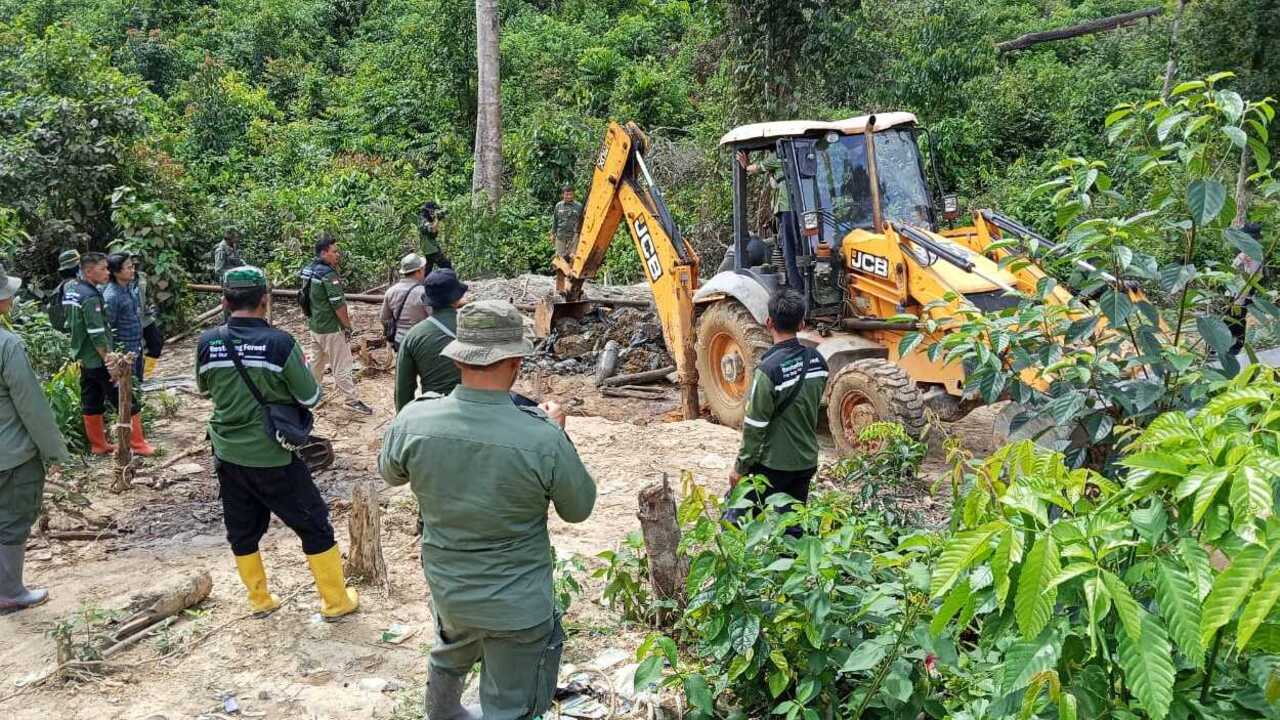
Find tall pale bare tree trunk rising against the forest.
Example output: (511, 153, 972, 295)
(471, 0, 502, 206)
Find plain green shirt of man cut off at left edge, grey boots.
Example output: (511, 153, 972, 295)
(0, 328, 67, 471)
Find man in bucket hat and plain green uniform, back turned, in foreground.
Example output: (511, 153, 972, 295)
(378, 301, 595, 720)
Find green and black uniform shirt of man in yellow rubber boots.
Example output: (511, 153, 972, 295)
(196, 318, 320, 468)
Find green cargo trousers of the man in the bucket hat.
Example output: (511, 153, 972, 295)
(429, 615, 564, 720)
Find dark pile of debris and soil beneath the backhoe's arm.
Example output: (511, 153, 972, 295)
(532, 307, 675, 375)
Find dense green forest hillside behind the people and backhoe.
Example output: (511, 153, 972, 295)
(0, 0, 1280, 319)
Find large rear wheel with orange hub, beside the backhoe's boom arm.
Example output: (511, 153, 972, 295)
(696, 300, 773, 428)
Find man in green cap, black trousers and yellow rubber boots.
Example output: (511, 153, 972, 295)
(196, 266, 358, 618)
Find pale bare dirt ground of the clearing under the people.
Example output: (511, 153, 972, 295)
(0, 281, 989, 720)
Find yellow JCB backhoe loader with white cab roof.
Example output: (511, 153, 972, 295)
(535, 118, 1090, 451)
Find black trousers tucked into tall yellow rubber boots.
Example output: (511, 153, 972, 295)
(214, 457, 337, 555)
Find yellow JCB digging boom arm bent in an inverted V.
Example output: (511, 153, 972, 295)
(542, 123, 700, 419)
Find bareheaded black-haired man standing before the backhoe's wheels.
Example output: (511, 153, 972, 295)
(730, 288, 827, 525)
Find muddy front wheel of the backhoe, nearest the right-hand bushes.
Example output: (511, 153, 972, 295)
(827, 359, 925, 456)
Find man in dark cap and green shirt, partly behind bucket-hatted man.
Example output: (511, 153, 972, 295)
(396, 269, 467, 413)
